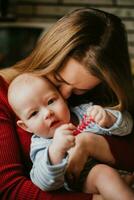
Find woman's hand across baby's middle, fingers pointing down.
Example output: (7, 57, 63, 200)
(66, 133, 89, 183)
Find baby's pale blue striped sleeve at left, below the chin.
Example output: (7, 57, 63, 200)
(30, 135, 67, 191)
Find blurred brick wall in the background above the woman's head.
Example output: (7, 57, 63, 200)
(8, 0, 134, 68)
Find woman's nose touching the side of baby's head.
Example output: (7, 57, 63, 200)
(59, 84, 73, 99)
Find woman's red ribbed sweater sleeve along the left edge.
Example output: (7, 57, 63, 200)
(0, 105, 46, 200)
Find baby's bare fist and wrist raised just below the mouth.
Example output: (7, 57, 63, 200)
(49, 123, 76, 164)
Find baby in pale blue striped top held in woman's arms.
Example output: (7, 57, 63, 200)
(8, 73, 134, 200)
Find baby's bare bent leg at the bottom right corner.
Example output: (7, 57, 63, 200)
(83, 164, 134, 200)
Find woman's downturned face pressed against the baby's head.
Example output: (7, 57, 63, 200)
(47, 58, 101, 99)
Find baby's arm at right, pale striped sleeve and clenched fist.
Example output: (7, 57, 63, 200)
(87, 105, 133, 136)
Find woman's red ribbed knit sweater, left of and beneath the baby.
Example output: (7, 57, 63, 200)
(0, 77, 92, 200)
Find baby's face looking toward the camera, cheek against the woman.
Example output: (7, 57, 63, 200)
(18, 78, 70, 138)
